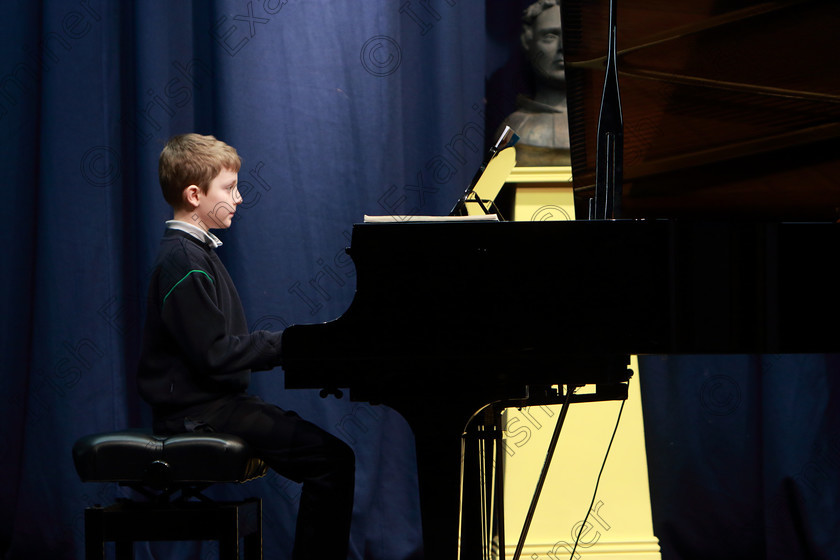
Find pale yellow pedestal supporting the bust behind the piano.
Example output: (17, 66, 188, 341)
(503, 168, 661, 560)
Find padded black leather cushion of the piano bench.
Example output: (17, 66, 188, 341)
(73, 430, 267, 486)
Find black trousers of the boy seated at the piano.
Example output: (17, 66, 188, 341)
(155, 393, 355, 560)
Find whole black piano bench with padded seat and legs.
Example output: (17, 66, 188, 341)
(73, 430, 267, 560)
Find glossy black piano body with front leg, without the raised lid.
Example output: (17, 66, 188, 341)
(283, 220, 840, 558)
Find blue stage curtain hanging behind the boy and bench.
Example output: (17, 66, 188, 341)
(0, 0, 485, 559)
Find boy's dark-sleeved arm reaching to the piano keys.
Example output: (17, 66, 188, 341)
(161, 270, 282, 381)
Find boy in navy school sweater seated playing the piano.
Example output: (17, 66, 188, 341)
(137, 134, 355, 560)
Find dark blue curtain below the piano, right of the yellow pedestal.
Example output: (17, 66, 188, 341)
(639, 355, 840, 560)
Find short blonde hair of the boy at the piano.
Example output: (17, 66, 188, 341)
(158, 133, 242, 209)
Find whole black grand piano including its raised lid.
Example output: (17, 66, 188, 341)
(283, 0, 840, 559)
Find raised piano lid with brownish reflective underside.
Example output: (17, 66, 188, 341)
(562, 0, 840, 221)
